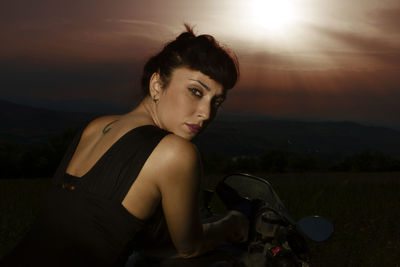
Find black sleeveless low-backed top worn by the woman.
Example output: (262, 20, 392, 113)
(2, 125, 169, 266)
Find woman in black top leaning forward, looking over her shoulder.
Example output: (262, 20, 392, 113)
(1, 25, 248, 266)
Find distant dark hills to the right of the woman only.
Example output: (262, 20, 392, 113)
(195, 116, 400, 157)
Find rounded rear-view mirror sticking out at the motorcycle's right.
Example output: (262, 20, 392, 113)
(297, 216, 333, 242)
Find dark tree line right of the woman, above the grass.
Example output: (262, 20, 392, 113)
(203, 149, 400, 173)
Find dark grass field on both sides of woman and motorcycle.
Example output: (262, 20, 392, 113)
(0, 173, 400, 267)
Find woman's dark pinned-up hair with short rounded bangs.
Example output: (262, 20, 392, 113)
(141, 24, 239, 95)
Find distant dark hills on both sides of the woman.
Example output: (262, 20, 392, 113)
(0, 100, 400, 156)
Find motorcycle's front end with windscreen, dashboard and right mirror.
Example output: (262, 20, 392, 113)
(212, 173, 333, 267)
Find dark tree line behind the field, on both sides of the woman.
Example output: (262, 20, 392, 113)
(0, 128, 400, 178)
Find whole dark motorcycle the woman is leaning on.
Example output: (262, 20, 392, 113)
(127, 173, 334, 267)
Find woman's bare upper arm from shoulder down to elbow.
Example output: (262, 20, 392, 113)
(155, 135, 203, 256)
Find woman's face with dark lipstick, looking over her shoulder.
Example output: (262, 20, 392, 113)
(153, 67, 225, 140)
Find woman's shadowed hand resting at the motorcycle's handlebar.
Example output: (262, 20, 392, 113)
(227, 210, 249, 243)
